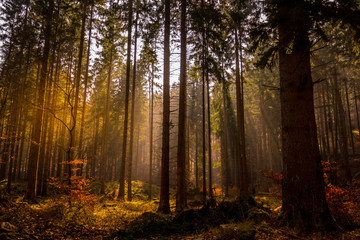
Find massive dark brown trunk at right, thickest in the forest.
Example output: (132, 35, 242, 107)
(278, 2, 334, 232)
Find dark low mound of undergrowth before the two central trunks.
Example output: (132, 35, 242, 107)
(113, 196, 261, 239)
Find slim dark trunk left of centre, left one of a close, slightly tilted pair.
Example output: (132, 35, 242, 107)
(118, 0, 133, 201)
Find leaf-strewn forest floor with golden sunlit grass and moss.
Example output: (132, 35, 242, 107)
(0, 182, 360, 240)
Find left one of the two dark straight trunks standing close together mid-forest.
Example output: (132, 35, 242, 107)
(158, 0, 170, 213)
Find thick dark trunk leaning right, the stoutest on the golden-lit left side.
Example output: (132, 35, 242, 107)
(25, 0, 54, 201)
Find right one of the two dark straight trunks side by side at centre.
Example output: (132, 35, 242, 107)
(176, 0, 187, 211)
